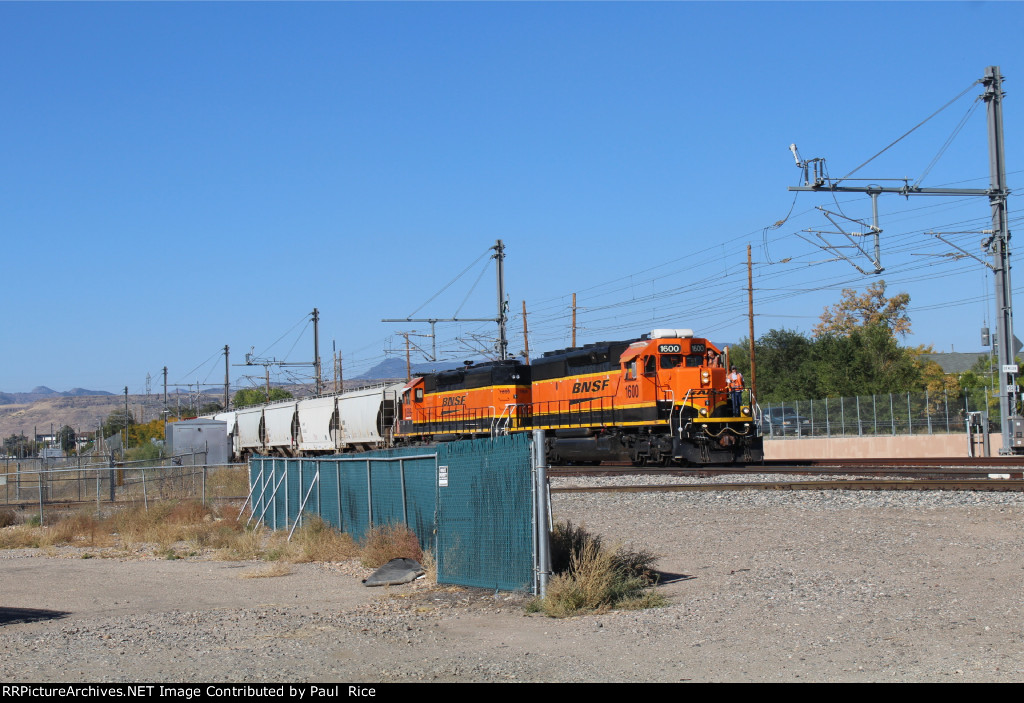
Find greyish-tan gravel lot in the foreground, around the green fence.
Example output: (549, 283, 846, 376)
(0, 477, 1024, 683)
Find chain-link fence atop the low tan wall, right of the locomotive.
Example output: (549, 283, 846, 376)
(758, 391, 998, 439)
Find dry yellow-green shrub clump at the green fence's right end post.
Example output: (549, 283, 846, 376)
(530, 522, 666, 617)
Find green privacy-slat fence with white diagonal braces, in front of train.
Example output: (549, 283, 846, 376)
(249, 435, 535, 590)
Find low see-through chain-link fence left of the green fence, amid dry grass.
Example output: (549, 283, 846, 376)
(0, 452, 249, 524)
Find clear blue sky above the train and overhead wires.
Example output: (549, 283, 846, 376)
(0, 2, 1024, 393)
